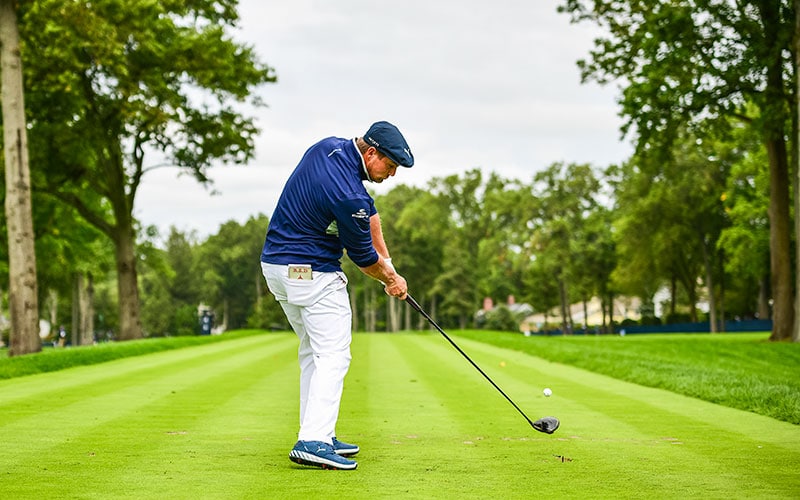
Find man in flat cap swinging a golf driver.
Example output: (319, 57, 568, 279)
(261, 121, 414, 469)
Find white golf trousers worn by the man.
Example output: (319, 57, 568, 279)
(261, 262, 352, 444)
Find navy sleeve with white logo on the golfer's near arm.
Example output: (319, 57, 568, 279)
(333, 198, 378, 267)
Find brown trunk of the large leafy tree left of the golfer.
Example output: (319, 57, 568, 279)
(114, 226, 143, 340)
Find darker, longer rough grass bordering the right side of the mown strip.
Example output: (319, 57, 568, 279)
(455, 330, 800, 424)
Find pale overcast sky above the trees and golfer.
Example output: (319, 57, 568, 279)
(134, 0, 632, 237)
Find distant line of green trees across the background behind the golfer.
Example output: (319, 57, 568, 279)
(1, 143, 771, 343)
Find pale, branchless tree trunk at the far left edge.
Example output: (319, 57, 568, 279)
(0, 0, 42, 356)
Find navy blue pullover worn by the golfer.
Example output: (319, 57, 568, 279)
(261, 137, 378, 272)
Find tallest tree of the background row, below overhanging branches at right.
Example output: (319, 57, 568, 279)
(617, 129, 732, 331)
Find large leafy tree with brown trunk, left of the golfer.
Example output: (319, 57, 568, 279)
(22, 0, 275, 340)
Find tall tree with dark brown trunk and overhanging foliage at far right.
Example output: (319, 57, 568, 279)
(559, 0, 795, 340)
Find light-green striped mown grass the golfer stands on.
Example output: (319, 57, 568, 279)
(0, 334, 800, 499)
